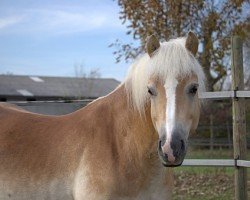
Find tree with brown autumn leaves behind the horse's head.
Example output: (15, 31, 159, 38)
(111, 0, 250, 91)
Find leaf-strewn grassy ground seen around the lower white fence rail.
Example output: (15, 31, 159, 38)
(173, 149, 250, 200)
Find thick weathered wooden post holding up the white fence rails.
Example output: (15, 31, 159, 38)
(231, 36, 247, 200)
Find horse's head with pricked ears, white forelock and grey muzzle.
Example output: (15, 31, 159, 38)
(145, 32, 203, 166)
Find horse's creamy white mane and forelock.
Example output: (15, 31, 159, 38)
(124, 38, 205, 113)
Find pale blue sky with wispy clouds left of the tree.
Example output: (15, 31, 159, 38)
(0, 0, 137, 81)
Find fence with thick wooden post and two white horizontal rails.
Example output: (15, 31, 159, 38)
(182, 36, 250, 200)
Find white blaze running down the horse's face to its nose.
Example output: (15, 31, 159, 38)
(162, 78, 178, 162)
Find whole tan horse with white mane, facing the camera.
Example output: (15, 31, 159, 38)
(0, 32, 204, 200)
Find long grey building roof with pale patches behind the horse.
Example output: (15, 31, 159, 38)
(0, 75, 120, 101)
